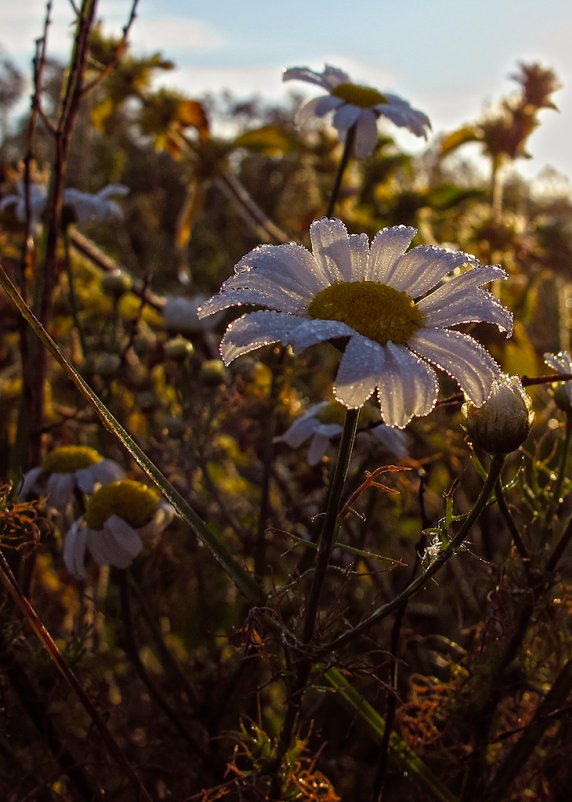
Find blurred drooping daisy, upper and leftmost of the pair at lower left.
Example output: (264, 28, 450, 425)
(18, 446, 125, 512)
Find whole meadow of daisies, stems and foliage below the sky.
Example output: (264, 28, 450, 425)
(0, 0, 572, 802)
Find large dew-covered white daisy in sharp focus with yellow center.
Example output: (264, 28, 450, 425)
(199, 218, 512, 428)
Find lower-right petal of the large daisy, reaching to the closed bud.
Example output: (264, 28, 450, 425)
(407, 329, 500, 406)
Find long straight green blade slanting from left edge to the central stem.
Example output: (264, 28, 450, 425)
(0, 265, 266, 605)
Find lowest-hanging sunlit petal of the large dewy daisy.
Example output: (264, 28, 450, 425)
(377, 342, 438, 429)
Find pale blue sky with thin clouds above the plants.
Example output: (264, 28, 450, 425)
(4, 0, 572, 184)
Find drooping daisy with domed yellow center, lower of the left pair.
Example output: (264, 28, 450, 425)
(64, 479, 174, 579)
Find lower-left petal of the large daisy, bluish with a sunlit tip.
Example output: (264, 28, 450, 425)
(220, 312, 301, 365)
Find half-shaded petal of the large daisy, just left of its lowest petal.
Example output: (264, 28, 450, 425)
(334, 334, 384, 409)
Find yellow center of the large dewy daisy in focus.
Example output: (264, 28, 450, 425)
(308, 281, 423, 345)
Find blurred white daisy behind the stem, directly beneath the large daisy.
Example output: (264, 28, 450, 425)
(274, 401, 407, 466)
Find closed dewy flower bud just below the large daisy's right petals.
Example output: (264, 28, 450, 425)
(462, 376, 534, 454)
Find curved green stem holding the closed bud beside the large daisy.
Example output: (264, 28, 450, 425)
(319, 454, 505, 655)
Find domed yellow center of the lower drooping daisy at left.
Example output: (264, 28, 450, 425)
(85, 479, 160, 529)
